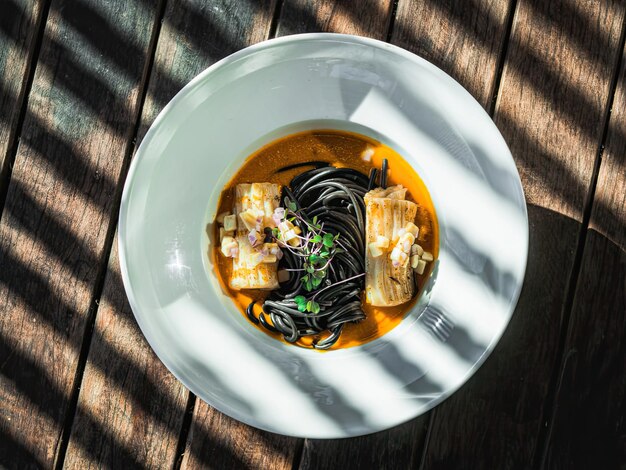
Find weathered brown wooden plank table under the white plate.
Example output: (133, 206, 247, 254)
(0, 0, 626, 469)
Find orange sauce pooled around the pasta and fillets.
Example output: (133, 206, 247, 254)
(212, 130, 439, 349)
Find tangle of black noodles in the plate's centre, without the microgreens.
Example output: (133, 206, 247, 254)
(254, 162, 376, 349)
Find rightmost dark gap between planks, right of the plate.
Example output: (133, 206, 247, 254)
(533, 14, 626, 469)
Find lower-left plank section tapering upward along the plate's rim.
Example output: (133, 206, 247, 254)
(64, 240, 188, 469)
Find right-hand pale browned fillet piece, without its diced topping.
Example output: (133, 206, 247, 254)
(364, 186, 417, 307)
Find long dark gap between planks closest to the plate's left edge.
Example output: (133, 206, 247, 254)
(51, 0, 167, 464)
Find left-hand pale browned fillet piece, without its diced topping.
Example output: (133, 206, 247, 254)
(229, 183, 280, 290)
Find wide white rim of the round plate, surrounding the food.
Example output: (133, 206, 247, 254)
(119, 34, 528, 438)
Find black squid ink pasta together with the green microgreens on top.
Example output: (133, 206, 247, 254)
(246, 160, 387, 349)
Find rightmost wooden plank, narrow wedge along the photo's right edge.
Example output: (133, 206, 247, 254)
(543, 35, 626, 469)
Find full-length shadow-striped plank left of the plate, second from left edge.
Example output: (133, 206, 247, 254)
(0, 0, 156, 468)
